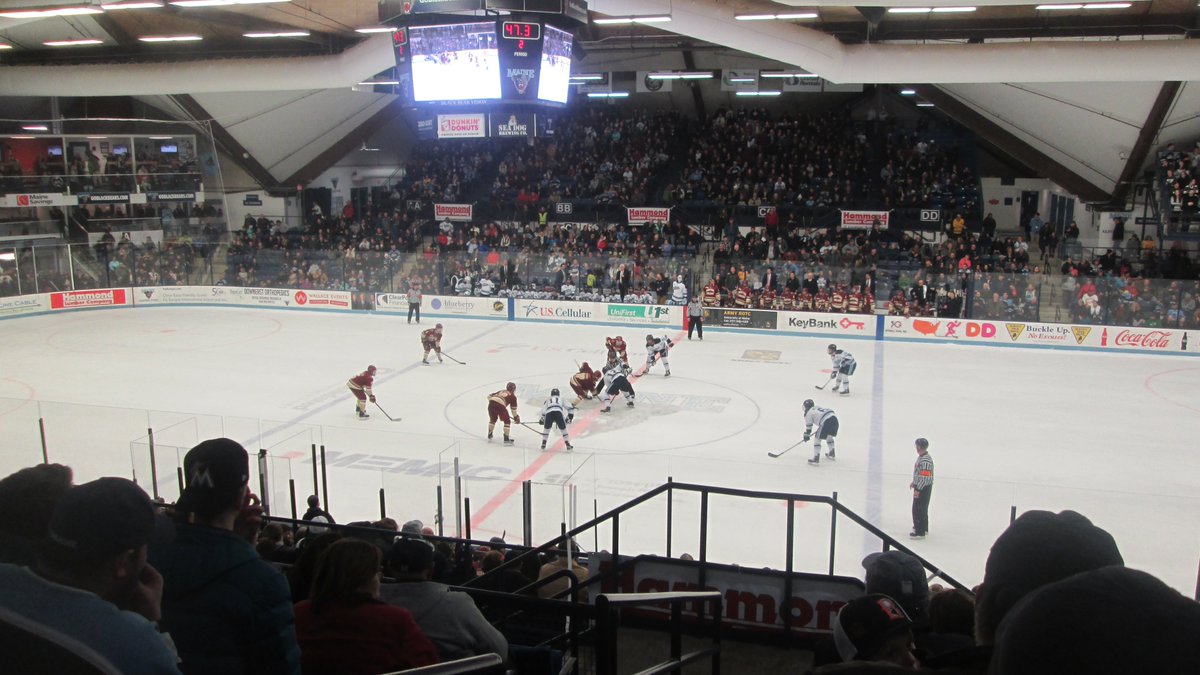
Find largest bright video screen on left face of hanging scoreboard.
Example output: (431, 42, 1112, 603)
(408, 22, 500, 102)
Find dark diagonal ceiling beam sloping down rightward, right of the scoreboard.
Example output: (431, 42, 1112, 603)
(913, 84, 1110, 203)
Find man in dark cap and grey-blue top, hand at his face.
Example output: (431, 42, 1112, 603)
(0, 478, 179, 675)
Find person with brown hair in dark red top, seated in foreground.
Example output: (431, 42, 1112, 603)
(295, 538, 438, 675)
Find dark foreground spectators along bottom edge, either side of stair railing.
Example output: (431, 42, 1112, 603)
(0, 438, 1200, 675)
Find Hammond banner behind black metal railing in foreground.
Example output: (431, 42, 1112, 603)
(588, 554, 863, 635)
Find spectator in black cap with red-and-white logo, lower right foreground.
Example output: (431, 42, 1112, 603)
(833, 593, 917, 669)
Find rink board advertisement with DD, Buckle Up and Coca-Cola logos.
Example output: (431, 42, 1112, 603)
(881, 316, 1196, 353)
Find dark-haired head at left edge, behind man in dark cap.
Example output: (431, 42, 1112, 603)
(0, 464, 72, 566)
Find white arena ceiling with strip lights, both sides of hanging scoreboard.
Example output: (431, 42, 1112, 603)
(0, 0, 1200, 202)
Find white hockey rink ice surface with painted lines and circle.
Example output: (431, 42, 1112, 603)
(0, 307, 1200, 596)
